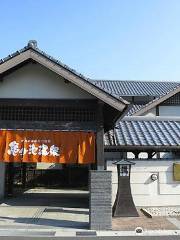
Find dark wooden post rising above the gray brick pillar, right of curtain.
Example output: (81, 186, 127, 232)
(96, 101, 105, 170)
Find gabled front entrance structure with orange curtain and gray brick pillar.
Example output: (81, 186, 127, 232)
(0, 41, 128, 229)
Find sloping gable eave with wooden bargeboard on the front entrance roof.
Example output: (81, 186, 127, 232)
(0, 47, 129, 112)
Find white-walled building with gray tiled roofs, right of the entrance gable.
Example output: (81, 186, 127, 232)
(102, 81, 180, 206)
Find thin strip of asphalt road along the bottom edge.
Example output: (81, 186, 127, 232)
(0, 236, 180, 240)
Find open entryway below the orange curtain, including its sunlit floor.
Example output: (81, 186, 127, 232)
(0, 163, 89, 230)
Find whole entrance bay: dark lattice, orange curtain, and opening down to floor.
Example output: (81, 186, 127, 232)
(0, 100, 97, 229)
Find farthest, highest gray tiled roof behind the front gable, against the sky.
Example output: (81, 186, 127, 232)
(92, 80, 180, 97)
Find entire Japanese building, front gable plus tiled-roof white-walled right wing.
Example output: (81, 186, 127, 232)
(0, 41, 180, 230)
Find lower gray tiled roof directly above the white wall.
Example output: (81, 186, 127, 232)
(104, 117, 180, 147)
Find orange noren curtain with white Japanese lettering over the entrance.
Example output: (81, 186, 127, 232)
(0, 130, 95, 164)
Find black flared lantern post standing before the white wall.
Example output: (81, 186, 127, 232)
(113, 159, 139, 217)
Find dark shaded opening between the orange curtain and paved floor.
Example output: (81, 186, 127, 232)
(5, 163, 89, 196)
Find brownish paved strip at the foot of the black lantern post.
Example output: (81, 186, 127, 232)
(113, 209, 180, 231)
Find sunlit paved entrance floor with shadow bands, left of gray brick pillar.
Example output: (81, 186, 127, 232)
(0, 189, 89, 231)
